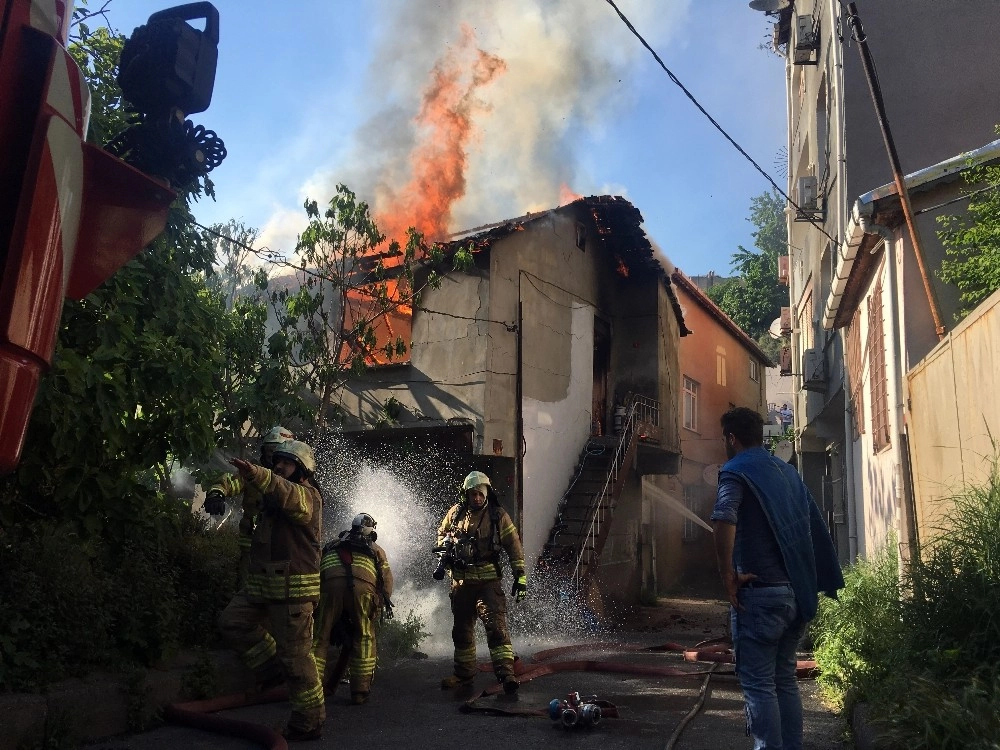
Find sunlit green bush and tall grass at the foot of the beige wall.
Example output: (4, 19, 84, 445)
(813, 462, 1000, 750)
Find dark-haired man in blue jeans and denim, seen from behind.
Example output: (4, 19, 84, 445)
(712, 407, 844, 750)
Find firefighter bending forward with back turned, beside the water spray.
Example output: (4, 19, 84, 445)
(313, 513, 392, 706)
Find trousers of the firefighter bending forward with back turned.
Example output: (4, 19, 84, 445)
(313, 576, 380, 694)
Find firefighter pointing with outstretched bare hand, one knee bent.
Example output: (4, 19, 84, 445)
(219, 440, 326, 741)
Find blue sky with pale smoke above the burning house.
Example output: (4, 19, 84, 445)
(103, 0, 786, 275)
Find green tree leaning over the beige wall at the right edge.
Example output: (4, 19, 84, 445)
(938, 165, 1000, 320)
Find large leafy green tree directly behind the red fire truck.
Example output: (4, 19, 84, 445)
(2, 8, 223, 538)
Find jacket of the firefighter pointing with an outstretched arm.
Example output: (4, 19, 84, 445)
(245, 464, 323, 602)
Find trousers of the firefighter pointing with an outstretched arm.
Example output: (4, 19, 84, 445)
(219, 594, 326, 732)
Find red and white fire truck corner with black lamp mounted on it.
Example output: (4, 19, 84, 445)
(0, 0, 225, 473)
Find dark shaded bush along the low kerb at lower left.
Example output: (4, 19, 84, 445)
(0, 513, 238, 691)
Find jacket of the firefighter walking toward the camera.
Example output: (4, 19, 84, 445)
(437, 500, 524, 581)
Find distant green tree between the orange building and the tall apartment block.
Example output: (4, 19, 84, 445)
(708, 191, 788, 340)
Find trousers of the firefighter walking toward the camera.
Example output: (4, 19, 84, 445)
(451, 580, 514, 681)
